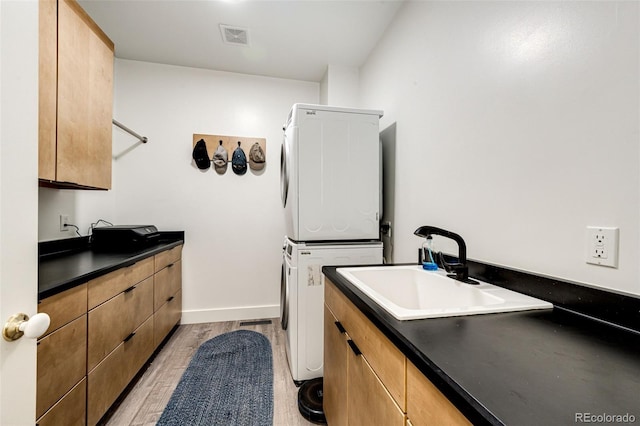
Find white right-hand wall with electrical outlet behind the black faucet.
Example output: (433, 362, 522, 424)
(359, 1, 640, 294)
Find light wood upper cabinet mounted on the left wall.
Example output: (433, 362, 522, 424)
(38, 0, 114, 189)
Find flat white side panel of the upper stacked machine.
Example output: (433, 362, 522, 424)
(298, 111, 380, 241)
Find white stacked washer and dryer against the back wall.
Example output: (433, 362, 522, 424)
(280, 104, 383, 392)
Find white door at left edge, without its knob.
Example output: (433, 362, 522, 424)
(0, 0, 38, 426)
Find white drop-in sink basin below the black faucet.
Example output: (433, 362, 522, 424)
(336, 266, 553, 320)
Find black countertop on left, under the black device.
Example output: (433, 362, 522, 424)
(38, 232, 184, 300)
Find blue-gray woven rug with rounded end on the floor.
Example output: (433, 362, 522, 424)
(157, 330, 273, 426)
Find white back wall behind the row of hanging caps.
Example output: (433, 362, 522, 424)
(40, 59, 319, 323)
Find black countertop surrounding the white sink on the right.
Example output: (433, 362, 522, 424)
(323, 266, 640, 426)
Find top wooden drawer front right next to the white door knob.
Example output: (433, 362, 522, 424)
(38, 284, 87, 336)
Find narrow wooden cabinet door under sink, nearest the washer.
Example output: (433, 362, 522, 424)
(322, 305, 348, 426)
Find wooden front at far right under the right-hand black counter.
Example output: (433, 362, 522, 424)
(407, 362, 471, 425)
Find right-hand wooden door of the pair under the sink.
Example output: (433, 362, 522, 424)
(347, 350, 404, 426)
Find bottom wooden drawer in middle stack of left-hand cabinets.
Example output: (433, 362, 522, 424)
(87, 318, 153, 425)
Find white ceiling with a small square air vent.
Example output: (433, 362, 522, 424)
(79, 0, 403, 82)
